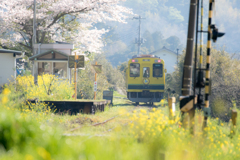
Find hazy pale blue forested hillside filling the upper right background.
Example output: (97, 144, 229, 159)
(116, 0, 240, 54)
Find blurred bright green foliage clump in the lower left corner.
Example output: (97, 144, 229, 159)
(0, 94, 77, 160)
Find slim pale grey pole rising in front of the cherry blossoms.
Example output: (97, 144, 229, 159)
(32, 0, 38, 85)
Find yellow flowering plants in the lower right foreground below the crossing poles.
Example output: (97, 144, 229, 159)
(129, 108, 240, 159)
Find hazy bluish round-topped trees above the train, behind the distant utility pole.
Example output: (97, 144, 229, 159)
(105, 30, 183, 66)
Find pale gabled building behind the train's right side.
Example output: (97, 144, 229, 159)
(149, 46, 178, 73)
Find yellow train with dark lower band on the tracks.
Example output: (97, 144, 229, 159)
(126, 55, 165, 105)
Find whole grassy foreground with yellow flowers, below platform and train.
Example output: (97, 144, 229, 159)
(0, 92, 240, 160)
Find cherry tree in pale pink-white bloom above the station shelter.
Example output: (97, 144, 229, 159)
(0, 0, 132, 54)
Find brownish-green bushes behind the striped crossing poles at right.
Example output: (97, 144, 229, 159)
(166, 47, 240, 121)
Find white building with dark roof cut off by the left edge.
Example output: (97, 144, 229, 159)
(0, 49, 22, 88)
